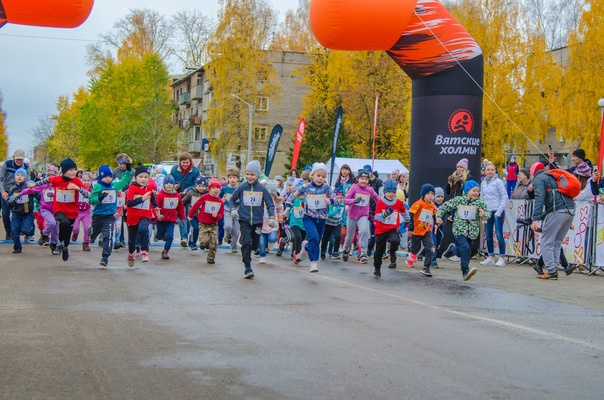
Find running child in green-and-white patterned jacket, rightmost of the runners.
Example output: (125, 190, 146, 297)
(436, 180, 490, 281)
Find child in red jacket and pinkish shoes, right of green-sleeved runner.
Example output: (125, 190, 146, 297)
(126, 165, 159, 268)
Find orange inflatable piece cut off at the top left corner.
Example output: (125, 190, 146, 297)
(0, 0, 94, 28)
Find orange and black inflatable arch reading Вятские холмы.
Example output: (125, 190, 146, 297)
(310, 0, 484, 200)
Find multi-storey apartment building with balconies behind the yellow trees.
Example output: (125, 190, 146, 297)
(171, 51, 310, 176)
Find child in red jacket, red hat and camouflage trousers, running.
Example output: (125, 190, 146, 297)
(189, 178, 224, 264)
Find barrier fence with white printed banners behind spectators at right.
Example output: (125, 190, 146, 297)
(480, 200, 604, 275)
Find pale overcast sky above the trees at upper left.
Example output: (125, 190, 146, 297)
(0, 0, 298, 160)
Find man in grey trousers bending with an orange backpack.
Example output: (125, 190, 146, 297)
(531, 164, 581, 279)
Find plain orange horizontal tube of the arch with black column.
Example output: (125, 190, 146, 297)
(310, 0, 417, 51)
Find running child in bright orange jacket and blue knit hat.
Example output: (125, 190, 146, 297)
(407, 183, 438, 277)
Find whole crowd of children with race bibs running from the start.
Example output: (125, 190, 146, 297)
(2, 153, 496, 279)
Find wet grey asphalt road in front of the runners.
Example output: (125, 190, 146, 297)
(0, 244, 604, 400)
